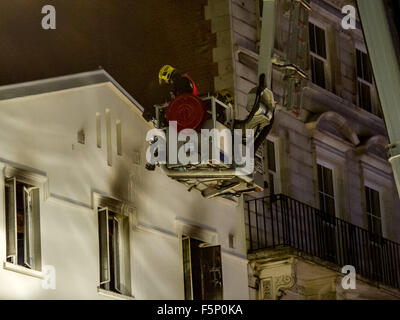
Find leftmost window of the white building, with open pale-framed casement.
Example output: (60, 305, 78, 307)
(5, 177, 42, 271)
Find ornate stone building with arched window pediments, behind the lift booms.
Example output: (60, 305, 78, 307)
(219, 0, 400, 299)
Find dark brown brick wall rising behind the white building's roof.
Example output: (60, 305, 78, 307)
(0, 0, 215, 110)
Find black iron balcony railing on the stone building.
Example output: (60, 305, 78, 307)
(246, 195, 400, 289)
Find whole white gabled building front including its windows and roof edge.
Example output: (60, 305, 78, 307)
(0, 70, 248, 299)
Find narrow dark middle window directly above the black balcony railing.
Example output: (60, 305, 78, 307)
(318, 165, 335, 216)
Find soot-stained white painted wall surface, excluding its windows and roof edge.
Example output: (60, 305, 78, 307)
(0, 83, 248, 299)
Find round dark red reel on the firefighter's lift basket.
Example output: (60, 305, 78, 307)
(167, 93, 207, 132)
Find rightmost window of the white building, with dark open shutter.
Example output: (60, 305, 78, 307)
(182, 236, 223, 300)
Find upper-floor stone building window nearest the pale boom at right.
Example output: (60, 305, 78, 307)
(356, 49, 372, 112)
